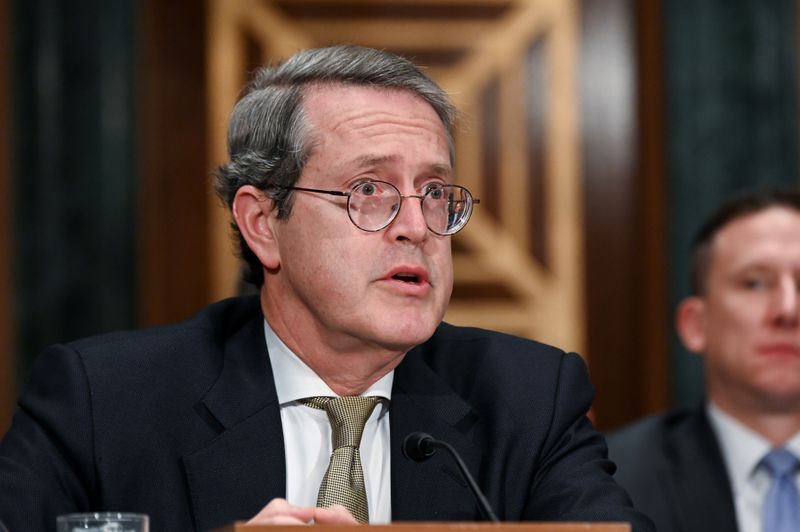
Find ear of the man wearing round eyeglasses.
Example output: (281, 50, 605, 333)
(231, 185, 281, 269)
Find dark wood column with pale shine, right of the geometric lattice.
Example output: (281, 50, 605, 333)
(580, 0, 672, 428)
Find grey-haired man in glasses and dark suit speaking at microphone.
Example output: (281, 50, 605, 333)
(0, 46, 650, 531)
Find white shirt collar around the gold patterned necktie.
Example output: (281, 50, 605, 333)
(264, 320, 394, 406)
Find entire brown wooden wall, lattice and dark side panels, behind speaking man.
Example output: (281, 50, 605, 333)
(0, 0, 669, 430)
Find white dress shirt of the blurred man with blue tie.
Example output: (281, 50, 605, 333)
(708, 402, 800, 532)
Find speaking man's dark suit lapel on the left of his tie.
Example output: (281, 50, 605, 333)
(183, 313, 286, 530)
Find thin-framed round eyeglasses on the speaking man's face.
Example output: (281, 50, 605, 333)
(285, 181, 481, 236)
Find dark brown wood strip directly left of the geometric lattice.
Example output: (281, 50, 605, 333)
(137, 0, 211, 325)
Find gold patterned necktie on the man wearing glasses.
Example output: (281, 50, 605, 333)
(302, 396, 378, 523)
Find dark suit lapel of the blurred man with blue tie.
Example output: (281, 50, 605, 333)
(664, 408, 737, 532)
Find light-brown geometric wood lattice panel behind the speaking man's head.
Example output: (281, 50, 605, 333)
(207, 0, 586, 355)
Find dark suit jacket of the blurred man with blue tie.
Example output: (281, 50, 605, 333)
(608, 407, 737, 532)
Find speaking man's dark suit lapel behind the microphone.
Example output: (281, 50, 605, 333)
(390, 348, 481, 521)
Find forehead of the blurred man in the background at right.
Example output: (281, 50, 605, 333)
(712, 206, 800, 269)
